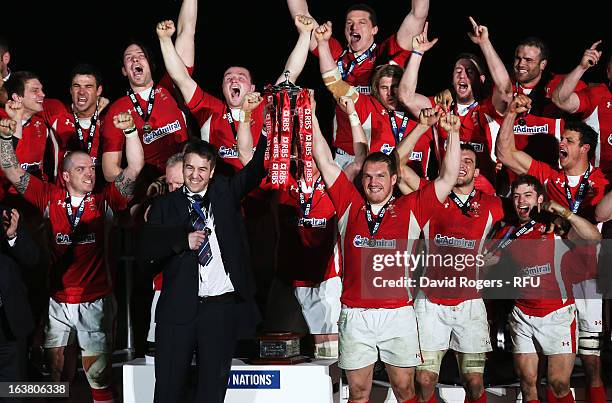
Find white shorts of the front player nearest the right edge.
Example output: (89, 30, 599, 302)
(572, 279, 603, 333)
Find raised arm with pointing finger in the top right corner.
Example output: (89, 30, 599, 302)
(552, 41, 601, 113)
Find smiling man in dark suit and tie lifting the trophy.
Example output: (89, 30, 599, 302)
(139, 115, 266, 403)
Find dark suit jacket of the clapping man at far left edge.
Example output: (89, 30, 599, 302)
(0, 206, 40, 338)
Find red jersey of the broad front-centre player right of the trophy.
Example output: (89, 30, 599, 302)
(328, 173, 442, 308)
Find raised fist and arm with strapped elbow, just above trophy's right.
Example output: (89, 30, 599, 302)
(314, 21, 359, 102)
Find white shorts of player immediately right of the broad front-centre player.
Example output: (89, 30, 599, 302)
(414, 297, 492, 353)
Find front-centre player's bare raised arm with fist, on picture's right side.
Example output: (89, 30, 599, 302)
(434, 114, 461, 203)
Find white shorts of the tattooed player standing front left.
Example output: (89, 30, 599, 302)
(44, 294, 117, 353)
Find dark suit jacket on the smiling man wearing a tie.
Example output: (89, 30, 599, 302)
(138, 136, 266, 337)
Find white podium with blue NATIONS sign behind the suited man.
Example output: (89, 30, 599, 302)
(123, 358, 341, 403)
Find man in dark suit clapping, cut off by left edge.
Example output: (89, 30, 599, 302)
(0, 205, 39, 401)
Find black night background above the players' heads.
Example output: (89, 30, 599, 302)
(0, 0, 612, 117)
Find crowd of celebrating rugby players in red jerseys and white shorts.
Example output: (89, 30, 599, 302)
(0, 0, 612, 402)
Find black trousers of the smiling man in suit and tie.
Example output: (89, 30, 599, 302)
(154, 300, 237, 403)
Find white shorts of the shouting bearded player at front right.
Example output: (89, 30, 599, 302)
(509, 304, 578, 355)
